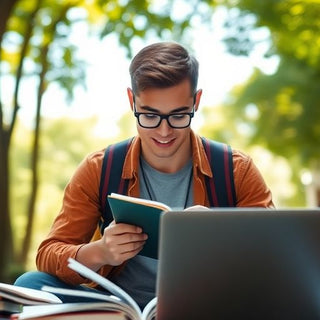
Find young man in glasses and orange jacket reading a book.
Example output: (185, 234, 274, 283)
(16, 42, 273, 307)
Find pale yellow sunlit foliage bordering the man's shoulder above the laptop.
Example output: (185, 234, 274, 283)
(197, 105, 305, 208)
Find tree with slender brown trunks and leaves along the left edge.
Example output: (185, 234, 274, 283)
(0, 0, 87, 278)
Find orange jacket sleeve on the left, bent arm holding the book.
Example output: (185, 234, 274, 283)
(36, 151, 116, 284)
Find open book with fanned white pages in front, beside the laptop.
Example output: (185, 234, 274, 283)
(11, 258, 157, 320)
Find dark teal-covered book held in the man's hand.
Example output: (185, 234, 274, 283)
(108, 193, 171, 259)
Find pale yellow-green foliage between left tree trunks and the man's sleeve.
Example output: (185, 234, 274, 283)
(10, 118, 110, 269)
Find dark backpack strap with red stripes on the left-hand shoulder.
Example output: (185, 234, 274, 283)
(99, 138, 133, 229)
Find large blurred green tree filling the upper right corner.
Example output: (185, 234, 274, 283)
(219, 0, 320, 205)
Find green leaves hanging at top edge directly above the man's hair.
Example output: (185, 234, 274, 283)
(98, 0, 211, 57)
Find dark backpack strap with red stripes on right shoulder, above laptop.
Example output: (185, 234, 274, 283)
(202, 138, 236, 207)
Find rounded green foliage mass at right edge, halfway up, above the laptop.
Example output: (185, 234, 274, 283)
(234, 58, 320, 166)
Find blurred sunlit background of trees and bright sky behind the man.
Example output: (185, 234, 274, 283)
(0, 0, 320, 282)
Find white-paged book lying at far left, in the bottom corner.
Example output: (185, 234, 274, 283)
(0, 283, 62, 305)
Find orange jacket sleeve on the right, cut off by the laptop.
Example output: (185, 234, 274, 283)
(233, 150, 274, 208)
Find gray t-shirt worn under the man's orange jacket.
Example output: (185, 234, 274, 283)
(111, 158, 193, 308)
